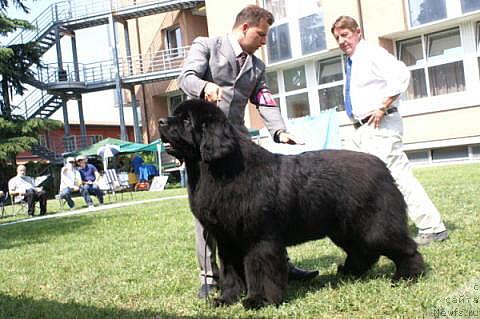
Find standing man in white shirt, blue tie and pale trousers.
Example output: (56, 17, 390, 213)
(331, 16, 448, 245)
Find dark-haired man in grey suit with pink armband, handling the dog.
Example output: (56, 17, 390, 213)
(178, 5, 318, 298)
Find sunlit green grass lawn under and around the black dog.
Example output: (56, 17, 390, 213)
(0, 164, 480, 318)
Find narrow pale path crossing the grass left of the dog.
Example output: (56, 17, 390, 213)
(0, 195, 188, 227)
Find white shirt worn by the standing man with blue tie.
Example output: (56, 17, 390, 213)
(350, 40, 410, 119)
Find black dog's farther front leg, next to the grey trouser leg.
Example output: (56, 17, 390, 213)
(214, 243, 245, 306)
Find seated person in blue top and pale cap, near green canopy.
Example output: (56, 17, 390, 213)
(77, 155, 103, 208)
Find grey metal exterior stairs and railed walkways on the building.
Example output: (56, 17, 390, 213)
(8, 0, 205, 118)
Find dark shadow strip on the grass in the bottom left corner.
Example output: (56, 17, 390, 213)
(0, 293, 221, 319)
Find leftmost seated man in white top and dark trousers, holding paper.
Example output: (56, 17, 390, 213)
(8, 165, 47, 216)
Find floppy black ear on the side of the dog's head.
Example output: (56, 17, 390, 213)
(200, 121, 236, 162)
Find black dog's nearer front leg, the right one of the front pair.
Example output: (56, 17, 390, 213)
(243, 241, 288, 309)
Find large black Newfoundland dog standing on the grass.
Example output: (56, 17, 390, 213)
(159, 100, 424, 308)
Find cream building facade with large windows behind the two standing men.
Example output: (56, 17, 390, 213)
(126, 0, 480, 164)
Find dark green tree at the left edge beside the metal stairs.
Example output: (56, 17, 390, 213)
(0, 0, 61, 168)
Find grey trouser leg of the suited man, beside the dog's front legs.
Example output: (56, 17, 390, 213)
(195, 218, 218, 284)
